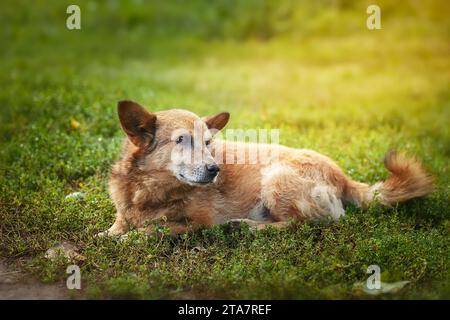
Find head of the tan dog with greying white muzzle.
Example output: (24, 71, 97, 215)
(118, 101, 230, 185)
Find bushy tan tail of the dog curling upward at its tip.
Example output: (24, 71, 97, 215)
(345, 151, 434, 206)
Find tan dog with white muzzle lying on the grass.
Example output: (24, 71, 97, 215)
(100, 101, 433, 236)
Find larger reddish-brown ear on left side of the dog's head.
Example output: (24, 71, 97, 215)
(117, 100, 156, 148)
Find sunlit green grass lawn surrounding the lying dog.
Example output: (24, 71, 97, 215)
(0, 1, 450, 299)
